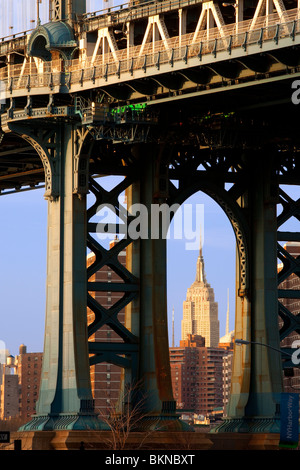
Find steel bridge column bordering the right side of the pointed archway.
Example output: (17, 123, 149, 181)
(217, 154, 283, 433)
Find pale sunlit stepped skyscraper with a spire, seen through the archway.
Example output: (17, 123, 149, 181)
(181, 243, 220, 348)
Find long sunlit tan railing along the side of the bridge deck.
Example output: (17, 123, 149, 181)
(0, 9, 300, 93)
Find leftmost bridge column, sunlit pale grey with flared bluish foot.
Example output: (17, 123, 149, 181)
(22, 124, 104, 431)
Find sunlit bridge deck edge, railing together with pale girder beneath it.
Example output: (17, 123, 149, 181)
(0, 10, 300, 106)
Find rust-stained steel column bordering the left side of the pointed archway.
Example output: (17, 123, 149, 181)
(129, 145, 189, 431)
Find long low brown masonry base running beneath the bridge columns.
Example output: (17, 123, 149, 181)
(0, 430, 280, 451)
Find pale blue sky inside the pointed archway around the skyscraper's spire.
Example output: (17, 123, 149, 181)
(167, 191, 236, 347)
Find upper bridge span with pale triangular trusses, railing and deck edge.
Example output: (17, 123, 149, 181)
(0, 0, 300, 107)
